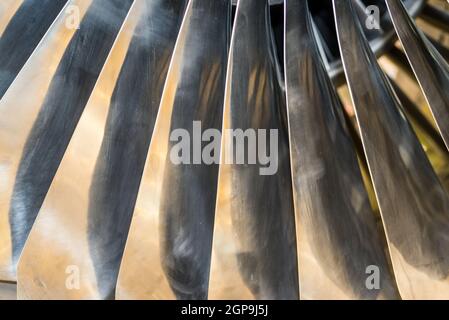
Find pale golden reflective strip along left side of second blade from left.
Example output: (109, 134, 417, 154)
(0, 0, 90, 281)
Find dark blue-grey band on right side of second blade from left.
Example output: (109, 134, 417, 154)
(9, 0, 132, 261)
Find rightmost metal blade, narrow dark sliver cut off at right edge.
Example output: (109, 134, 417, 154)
(386, 0, 449, 149)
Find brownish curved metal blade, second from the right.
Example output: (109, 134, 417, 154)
(334, 0, 449, 299)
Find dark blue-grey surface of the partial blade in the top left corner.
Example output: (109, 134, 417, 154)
(0, 0, 68, 99)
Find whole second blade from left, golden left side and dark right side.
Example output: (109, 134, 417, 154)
(0, 0, 132, 280)
